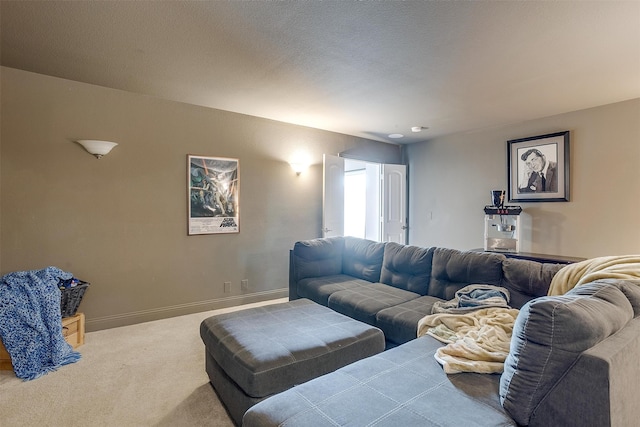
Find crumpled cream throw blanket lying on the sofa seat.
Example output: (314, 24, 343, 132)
(418, 307, 518, 374)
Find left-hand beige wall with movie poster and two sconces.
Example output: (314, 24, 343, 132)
(0, 68, 401, 330)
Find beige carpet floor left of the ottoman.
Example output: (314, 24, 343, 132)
(0, 298, 286, 427)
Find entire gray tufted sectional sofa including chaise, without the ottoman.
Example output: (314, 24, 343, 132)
(243, 237, 640, 427)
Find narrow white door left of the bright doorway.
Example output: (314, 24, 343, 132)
(322, 154, 344, 237)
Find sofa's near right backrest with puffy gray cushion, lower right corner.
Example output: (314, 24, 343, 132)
(500, 280, 640, 427)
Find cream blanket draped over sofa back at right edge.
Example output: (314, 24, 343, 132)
(548, 255, 640, 295)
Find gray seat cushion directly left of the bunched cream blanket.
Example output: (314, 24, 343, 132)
(376, 295, 442, 344)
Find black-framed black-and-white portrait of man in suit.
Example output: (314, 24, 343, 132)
(507, 131, 569, 202)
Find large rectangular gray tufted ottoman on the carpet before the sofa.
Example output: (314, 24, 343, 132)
(200, 299, 385, 425)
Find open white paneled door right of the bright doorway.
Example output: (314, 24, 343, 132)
(382, 165, 407, 245)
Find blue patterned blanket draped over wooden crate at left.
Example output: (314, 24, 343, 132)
(0, 267, 80, 380)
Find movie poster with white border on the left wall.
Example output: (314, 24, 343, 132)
(187, 155, 240, 235)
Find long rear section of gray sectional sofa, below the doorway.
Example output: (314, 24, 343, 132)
(289, 237, 563, 346)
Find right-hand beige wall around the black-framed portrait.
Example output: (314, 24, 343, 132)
(407, 99, 640, 258)
